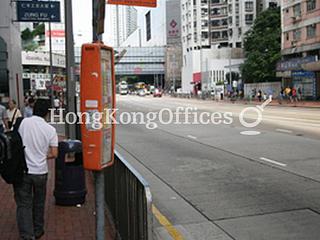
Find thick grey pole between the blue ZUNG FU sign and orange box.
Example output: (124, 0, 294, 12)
(64, 0, 76, 139)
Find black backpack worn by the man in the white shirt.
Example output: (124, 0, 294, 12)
(0, 119, 28, 184)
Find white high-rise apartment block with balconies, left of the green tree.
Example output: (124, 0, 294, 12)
(181, 0, 279, 92)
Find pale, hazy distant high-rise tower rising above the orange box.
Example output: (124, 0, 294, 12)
(105, 5, 138, 46)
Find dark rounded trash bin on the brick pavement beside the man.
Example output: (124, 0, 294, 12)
(54, 140, 87, 206)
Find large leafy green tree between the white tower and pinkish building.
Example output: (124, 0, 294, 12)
(240, 8, 281, 83)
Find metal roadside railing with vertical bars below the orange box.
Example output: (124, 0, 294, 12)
(105, 151, 153, 240)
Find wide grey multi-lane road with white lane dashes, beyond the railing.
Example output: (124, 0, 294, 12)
(116, 96, 320, 240)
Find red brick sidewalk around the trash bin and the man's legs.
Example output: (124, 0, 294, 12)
(0, 158, 114, 240)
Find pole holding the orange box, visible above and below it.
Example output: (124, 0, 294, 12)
(92, 0, 105, 240)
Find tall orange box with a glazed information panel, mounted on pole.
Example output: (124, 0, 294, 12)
(80, 43, 116, 171)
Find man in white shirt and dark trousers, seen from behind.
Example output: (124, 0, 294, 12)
(14, 99, 58, 240)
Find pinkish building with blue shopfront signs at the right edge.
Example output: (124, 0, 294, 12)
(277, 0, 320, 99)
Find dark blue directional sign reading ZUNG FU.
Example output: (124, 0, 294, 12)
(16, 1, 60, 22)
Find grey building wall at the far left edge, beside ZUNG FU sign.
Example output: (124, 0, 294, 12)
(0, 1, 23, 106)
